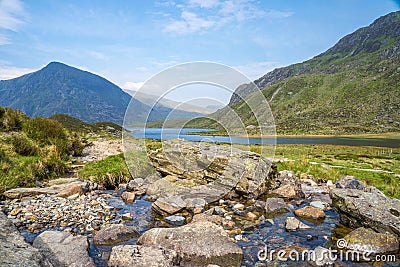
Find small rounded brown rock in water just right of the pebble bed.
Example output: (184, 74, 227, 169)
(93, 224, 139, 246)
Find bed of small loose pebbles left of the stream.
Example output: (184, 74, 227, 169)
(3, 195, 115, 236)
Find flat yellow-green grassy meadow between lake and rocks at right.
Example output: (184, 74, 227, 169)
(268, 145, 400, 198)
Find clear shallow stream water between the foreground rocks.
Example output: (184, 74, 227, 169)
(17, 194, 400, 267)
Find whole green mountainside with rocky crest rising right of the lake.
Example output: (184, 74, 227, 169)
(222, 11, 400, 134)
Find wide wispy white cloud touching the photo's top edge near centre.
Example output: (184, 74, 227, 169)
(164, 0, 294, 34)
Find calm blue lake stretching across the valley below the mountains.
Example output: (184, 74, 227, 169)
(128, 128, 400, 148)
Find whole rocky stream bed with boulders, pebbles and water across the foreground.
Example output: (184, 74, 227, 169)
(0, 142, 400, 267)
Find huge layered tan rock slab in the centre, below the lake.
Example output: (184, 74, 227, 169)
(149, 140, 279, 200)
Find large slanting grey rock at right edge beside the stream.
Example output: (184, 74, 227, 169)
(330, 188, 400, 236)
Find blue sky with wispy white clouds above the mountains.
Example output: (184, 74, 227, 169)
(0, 0, 400, 102)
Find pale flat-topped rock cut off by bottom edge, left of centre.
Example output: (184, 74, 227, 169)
(108, 245, 180, 267)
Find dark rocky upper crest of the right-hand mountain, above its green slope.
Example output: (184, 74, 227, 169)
(229, 11, 400, 105)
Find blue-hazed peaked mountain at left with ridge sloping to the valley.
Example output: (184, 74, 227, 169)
(0, 62, 205, 125)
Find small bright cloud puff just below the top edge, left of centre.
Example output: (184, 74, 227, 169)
(164, 11, 215, 34)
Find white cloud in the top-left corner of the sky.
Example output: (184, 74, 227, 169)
(0, 0, 25, 45)
